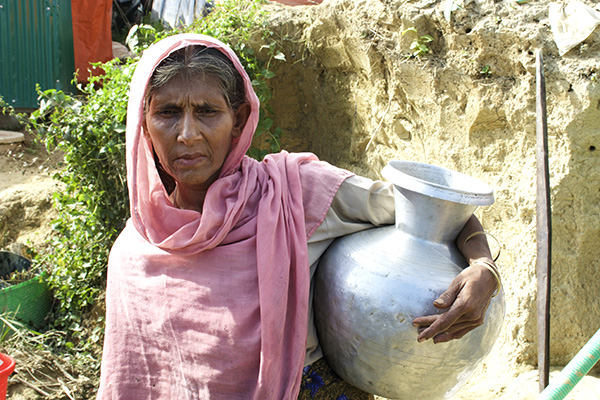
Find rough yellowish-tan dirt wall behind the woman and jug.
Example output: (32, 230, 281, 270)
(256, 0, 600, 382)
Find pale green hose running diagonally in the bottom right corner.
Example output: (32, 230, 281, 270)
(537, 329, 600, 400)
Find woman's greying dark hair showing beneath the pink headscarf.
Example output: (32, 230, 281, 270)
(144, 45, 246, 111)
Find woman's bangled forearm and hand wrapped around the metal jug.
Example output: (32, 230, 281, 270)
(413, 216, 500, 343)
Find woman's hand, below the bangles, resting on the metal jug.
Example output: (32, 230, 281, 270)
(413, 262, 498, 343)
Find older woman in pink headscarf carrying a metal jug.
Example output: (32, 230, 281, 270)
(98, 34, 496, 400)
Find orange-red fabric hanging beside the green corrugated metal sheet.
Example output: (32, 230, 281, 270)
(71, 0, 113, 82)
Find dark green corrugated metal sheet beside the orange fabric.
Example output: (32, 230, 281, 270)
(0, 0, 75, 108)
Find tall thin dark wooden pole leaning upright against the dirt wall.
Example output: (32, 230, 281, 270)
(535, 50, 552, 392)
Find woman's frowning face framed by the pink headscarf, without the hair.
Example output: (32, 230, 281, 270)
(144, 77, 247, 192)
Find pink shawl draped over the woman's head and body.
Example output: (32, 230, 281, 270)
(98, 34, 350, 400)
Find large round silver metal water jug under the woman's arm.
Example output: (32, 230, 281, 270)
(314, 161, 505, 400)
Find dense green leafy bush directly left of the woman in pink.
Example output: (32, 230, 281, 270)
(30, 57, 134, 351)
